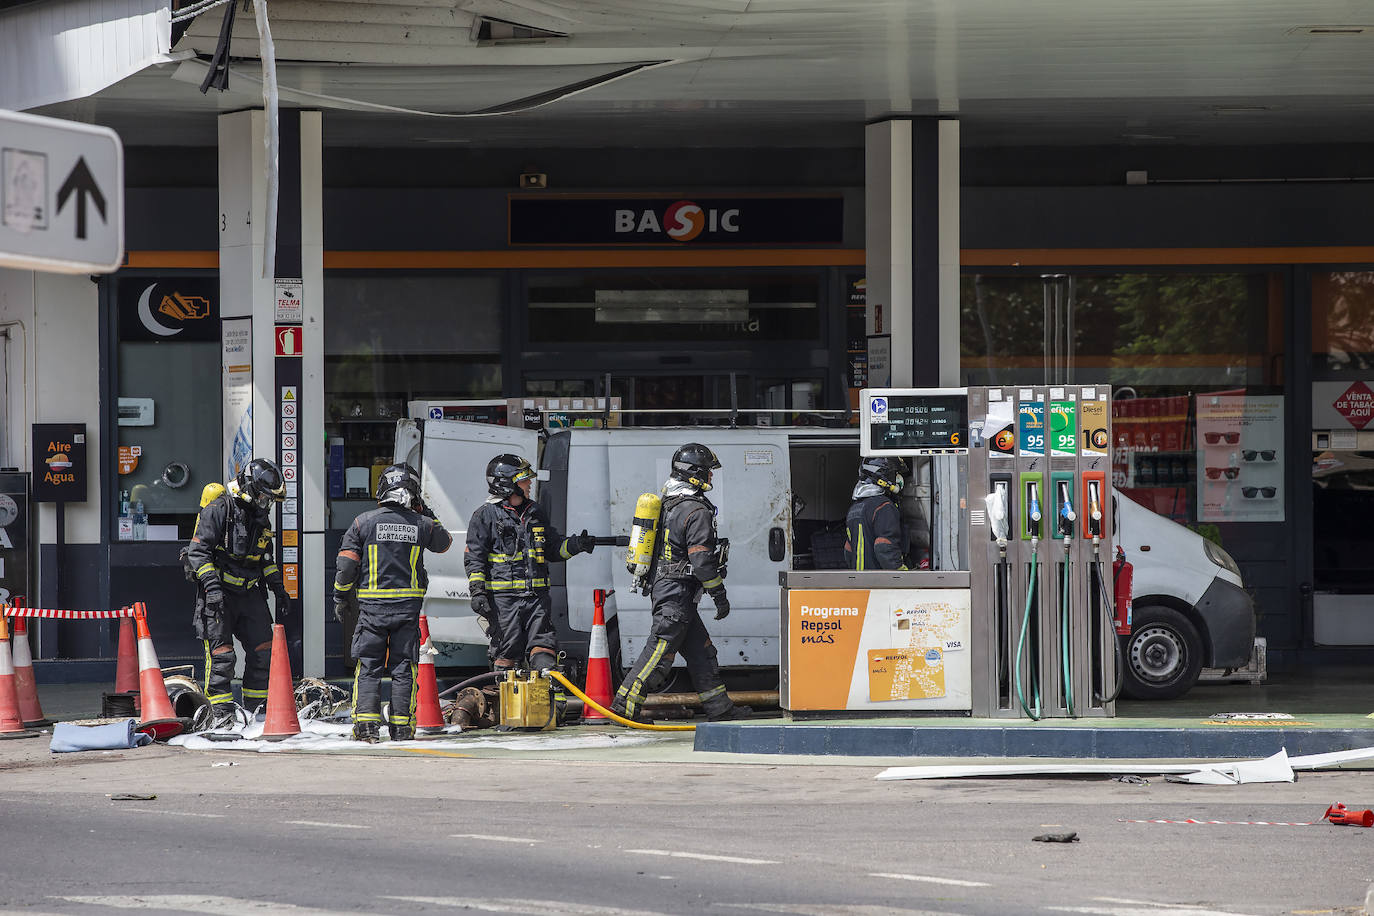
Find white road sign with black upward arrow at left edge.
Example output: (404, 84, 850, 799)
(0, 111, 124, 273)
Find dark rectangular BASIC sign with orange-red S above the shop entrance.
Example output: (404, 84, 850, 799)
(507, 194, 845, 246)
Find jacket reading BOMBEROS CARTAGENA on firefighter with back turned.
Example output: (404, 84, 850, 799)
(334, 505, 453, 607)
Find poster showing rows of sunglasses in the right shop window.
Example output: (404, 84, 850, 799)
(1197, 394, 1283, 522)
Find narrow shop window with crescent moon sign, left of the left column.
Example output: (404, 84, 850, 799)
(110, 276, 224, 541)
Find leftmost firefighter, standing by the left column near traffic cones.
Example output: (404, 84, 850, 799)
(187, 459, 291, 724)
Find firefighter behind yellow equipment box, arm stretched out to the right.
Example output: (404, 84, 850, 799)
(463, 455, 596, 672)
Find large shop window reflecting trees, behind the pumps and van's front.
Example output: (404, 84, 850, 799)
(960, 272, 1285, 525)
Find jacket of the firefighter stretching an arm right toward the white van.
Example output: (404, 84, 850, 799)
(463, 500, 578, 597)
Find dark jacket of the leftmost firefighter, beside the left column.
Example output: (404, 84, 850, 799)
(187, 493, 284, 593)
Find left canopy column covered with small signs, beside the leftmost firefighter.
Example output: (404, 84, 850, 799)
(218, 110, 324, 676)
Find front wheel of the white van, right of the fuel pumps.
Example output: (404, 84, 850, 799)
(1121, 604, 1202, 700)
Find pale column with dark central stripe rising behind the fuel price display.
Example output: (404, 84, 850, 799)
(864, 118, 960, 387)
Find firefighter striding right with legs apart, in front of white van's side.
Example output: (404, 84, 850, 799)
(611, 442, 749, 721)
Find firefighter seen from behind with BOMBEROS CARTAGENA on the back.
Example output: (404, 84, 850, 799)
(334, 464, 453, 743)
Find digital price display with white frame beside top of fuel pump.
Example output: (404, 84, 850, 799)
(859, 389, 969, 457)
